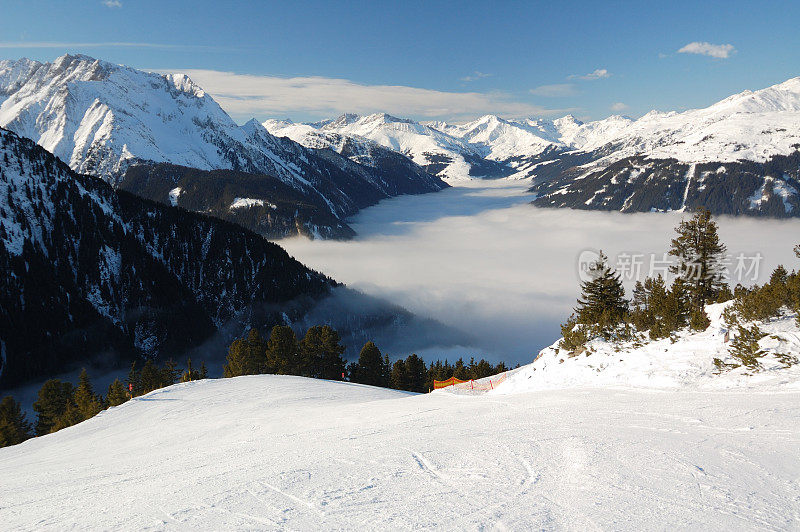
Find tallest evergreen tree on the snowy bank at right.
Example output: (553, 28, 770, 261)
(669, 209, 726, 309)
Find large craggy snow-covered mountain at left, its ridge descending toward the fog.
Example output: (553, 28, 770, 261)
(0, 55, 447, 236)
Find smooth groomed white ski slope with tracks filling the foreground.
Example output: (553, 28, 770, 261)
(0, 368, 800, 530)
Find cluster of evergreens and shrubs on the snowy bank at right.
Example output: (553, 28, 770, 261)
(559, 206, 800, 370)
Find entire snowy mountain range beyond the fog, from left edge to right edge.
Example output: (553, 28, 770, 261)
(0, 55, 800, 220)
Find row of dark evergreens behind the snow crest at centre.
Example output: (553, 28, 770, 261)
(223, 325, 508, 392)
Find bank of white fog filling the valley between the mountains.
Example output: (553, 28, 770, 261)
(279, 180, 800, 364)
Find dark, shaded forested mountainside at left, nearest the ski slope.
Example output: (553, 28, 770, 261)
(0, 128, 335, 386)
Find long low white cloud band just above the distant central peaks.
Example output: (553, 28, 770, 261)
(170, 70, 565, 120)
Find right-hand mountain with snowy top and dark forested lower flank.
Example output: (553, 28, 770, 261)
(531, 78, 800, 218)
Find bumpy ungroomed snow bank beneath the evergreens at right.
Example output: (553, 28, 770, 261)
(493, 303, 800, 394)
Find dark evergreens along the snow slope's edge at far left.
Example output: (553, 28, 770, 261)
(0, 359, 208, 447)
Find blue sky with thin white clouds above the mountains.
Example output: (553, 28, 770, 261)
(0, 0, 800, 122)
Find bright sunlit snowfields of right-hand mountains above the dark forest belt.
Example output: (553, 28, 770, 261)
(436, 77, 800, 167)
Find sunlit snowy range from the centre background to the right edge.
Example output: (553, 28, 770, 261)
(264, 78, 800, 217)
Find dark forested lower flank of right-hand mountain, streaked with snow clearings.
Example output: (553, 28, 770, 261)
(530, 152, 800, 218)
